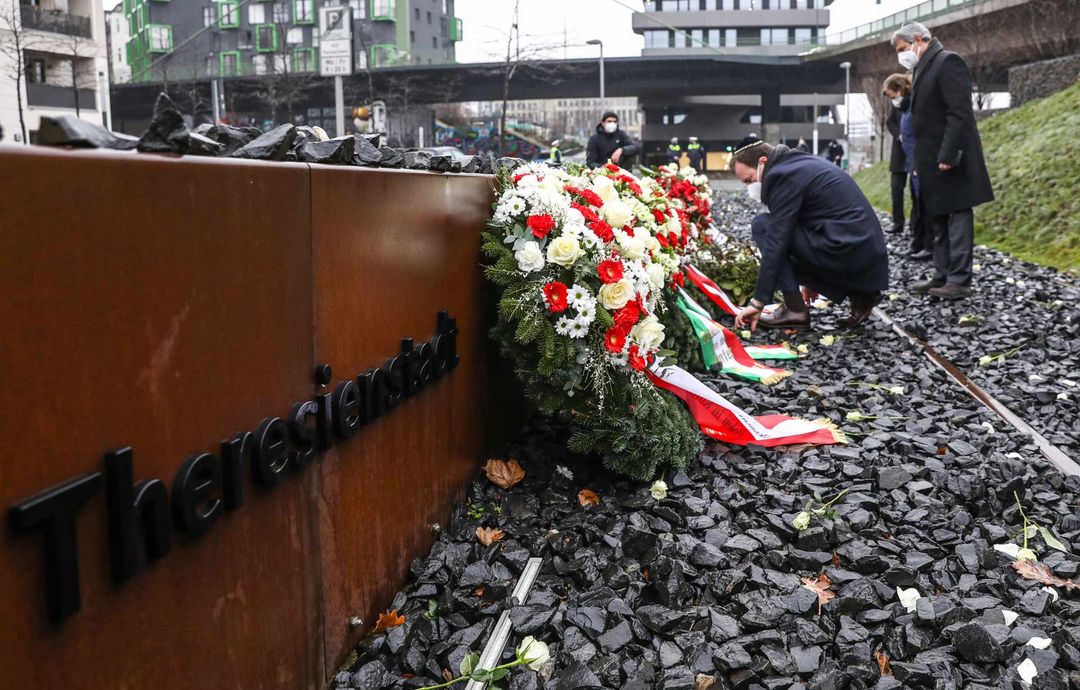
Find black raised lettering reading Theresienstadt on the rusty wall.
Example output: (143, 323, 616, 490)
(8, 312, 459, 623)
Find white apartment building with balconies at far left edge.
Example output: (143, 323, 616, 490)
(0, 0, 108, 143)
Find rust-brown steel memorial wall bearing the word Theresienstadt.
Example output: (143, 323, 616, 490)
(0, 147, 504, 690)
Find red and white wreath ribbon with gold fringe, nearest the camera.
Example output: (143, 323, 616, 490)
(646, 364, 847, 446)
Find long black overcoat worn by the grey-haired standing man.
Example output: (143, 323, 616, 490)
(912, 40, 994, 216)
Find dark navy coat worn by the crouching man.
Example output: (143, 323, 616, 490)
(754, 146, 889, 303)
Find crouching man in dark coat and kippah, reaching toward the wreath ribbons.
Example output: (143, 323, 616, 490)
(731, 139, 889, 330)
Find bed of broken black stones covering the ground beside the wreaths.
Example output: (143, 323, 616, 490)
(334, 190, 1080, 690)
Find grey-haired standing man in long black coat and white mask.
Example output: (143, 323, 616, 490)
(892, 22, 994, 299)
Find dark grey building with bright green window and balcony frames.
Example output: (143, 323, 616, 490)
(123, 0, 462, 82)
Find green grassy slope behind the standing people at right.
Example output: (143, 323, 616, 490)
(854, 83, 1080, 273)
